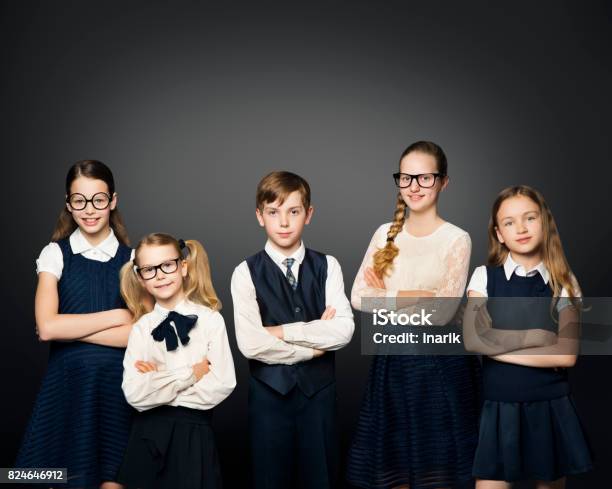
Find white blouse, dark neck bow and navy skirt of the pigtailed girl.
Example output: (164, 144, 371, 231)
(118, 300, 236, 489)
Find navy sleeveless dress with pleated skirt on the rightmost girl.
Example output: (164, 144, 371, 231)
(473, 267, 592, 482)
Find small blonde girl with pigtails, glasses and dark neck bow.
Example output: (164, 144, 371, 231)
(118, 233, 236, 489)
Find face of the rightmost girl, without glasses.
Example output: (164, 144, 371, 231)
(495, 195, 544, 256)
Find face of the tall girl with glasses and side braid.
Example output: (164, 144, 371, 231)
(400, 151, 448, 212)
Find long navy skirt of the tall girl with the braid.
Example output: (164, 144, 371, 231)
(347, 355, 481, 489)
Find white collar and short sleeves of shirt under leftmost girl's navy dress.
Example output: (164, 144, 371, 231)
(36, 228, 134, 280)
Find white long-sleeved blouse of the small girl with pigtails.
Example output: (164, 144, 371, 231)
(121, 300, 236, 411)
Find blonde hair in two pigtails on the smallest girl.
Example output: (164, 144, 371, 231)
(120, 233, 221, 321)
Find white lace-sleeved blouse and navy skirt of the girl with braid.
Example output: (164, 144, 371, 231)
(346, 222, 481, 489)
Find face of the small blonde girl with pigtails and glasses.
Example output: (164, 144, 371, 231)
(136, 244, 187, 308)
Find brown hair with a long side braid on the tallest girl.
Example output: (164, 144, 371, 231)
(373, 141, 448, 277)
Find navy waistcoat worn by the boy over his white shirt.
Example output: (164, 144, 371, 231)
(246, 249, 335, 397)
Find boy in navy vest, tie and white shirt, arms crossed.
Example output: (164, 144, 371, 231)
(232, 172, 355, 489)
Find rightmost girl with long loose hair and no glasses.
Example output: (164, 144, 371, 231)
(466, 185, 591, 489)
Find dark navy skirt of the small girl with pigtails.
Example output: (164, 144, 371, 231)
(118, 406, 222, 489)
